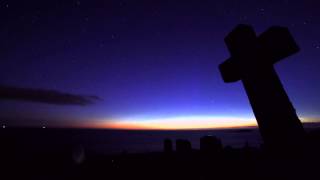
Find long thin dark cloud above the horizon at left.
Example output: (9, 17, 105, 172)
(0, 85, 100, 106)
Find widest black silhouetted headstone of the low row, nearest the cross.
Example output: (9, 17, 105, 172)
(200, 136, 222, 153)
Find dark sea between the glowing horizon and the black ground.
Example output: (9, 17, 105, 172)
(0, 128, 261, 154)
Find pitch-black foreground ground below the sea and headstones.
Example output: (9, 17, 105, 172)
(0, 127, 320, 180)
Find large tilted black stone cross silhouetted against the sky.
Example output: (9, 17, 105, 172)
(219, 24, 305, 149)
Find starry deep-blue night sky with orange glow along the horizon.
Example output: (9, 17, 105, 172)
(0, 0, 320, 129)
